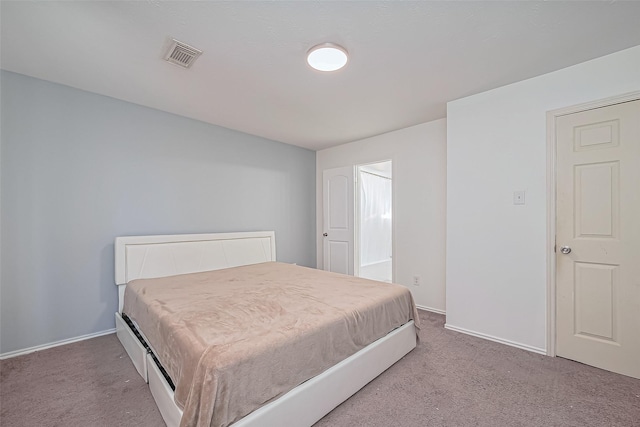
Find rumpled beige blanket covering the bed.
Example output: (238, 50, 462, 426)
(123, 262, 418, 427)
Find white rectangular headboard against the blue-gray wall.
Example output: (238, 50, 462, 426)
(115, 231, 276, 312)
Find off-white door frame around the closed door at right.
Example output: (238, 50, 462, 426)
(547, 91, 640, 357)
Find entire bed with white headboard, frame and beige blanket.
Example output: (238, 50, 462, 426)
(115, 232, 417, 427)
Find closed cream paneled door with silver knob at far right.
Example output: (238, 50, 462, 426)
(556, 100, 640, 378)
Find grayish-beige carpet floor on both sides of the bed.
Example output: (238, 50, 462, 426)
(0, 311, 640, 427)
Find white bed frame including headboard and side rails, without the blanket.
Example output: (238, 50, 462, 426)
(115, 231, 416, 427)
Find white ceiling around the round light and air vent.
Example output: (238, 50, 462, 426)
(0, 0, 640, 150)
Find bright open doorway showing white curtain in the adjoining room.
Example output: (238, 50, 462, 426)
(354, 160, 393, 283)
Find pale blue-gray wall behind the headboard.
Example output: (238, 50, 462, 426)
(0, 71, 316, 353)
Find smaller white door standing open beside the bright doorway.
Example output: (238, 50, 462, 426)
(322, 167, 354, 275)
